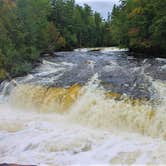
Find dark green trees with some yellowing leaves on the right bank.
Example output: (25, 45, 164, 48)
(110, 0, 166, 54)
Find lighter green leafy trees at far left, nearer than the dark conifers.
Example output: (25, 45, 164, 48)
(0, 0, 65, 75)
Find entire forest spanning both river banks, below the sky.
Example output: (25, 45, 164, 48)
(0, 0, 166, 80)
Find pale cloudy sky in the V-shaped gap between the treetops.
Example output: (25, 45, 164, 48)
(75, 0, 119, 18)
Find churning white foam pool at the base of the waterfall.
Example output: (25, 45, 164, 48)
(0, 105, 166, 166)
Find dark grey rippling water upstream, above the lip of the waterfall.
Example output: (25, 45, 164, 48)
(0, 51, 166, 99)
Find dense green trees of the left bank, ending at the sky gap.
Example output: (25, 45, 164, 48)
(0, 0, 109, 79)
